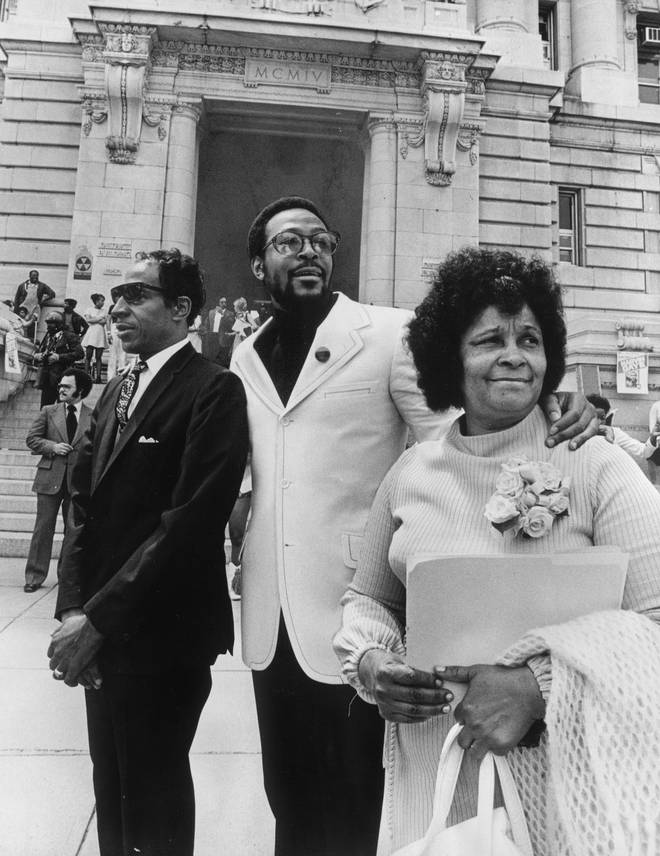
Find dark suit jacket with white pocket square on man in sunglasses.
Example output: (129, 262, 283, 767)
(56, 344, 248, 674)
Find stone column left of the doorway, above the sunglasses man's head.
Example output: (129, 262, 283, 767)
(161, 103, 201, 253)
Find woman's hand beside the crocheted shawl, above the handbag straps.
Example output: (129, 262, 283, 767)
(436, 666, 545, 760)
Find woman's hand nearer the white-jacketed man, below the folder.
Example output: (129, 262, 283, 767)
(358, 648, 454, 722)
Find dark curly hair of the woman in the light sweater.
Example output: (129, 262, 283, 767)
(408, 247, 566, 410)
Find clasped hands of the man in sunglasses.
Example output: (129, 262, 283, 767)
(48, 610, 103, 687)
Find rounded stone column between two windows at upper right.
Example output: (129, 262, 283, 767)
(566, 0, 637, 104)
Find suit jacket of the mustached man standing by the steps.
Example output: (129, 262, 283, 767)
(25, 402, 92, 494)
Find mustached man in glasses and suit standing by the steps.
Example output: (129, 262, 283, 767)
(23, 369, 92, 593)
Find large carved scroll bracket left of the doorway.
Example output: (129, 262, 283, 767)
(99, 24, 157, 164)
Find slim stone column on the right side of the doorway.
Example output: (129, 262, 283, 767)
(360, 116, 397, 306)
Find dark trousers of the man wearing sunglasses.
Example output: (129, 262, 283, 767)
(85, 666, 211, 856)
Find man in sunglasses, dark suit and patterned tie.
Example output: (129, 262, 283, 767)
(48, 250, 248, 856)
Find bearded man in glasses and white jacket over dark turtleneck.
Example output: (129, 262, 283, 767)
(232, 197, 596, 856)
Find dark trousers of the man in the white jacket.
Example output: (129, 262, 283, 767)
(252, 621, 384, 856)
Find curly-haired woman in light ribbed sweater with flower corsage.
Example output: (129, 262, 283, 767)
(334, 249, 660, 856)
